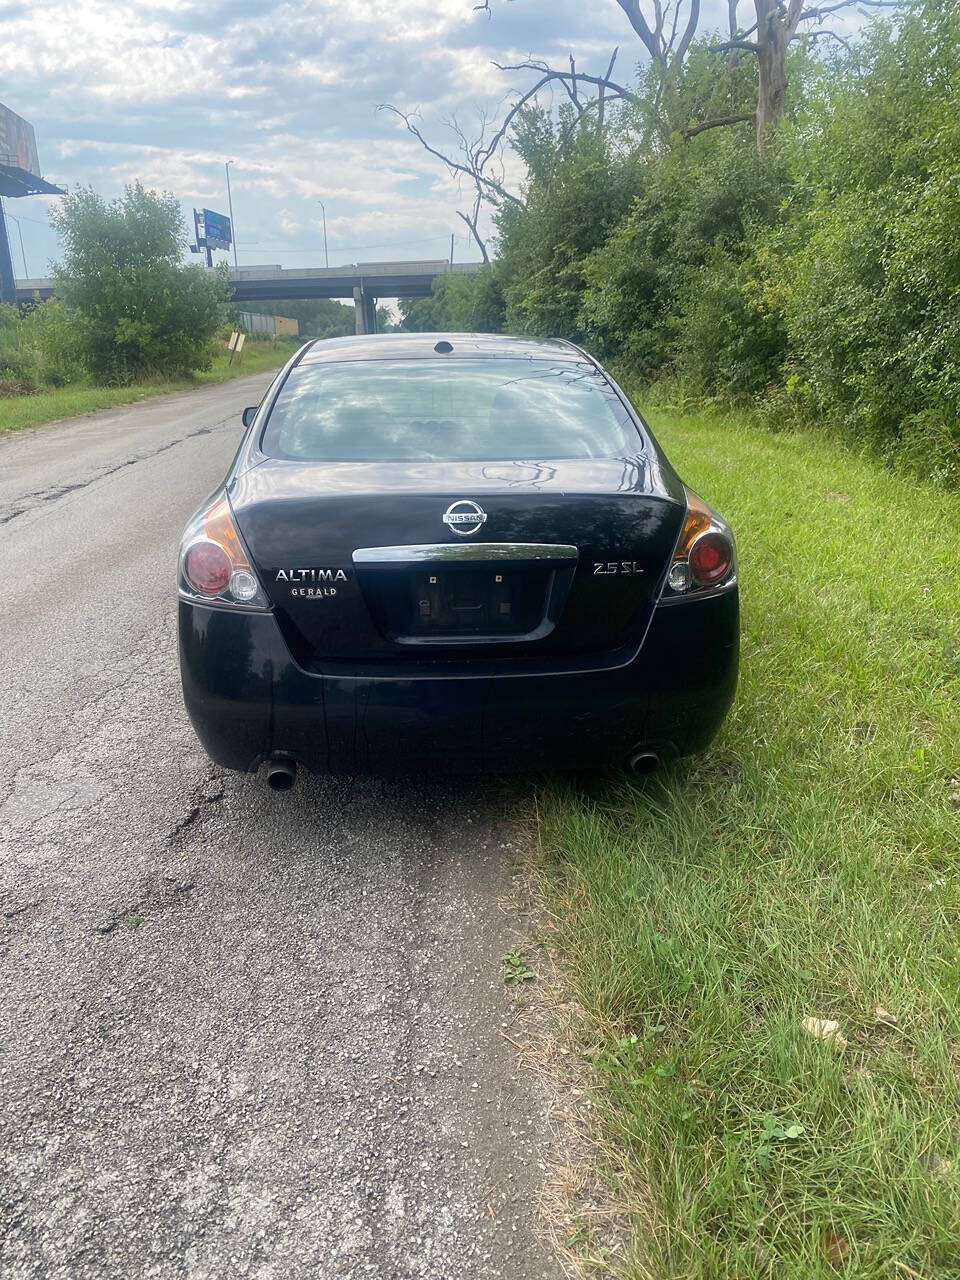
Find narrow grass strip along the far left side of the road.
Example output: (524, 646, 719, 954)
(0, 339, 298, 434)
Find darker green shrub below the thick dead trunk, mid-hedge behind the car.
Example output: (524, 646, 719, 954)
(580, 131, 786, 378)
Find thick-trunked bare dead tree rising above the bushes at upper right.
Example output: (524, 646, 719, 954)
(684, 0, 899, 154)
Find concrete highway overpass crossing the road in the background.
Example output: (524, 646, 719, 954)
(17, 260, 481, 333)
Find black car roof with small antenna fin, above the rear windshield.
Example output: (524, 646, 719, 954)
(297, 333, 590, 365)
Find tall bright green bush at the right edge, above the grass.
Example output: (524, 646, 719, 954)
(781, 3, 960, 480)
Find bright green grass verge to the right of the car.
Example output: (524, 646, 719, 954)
(539, 404, 960, 1280)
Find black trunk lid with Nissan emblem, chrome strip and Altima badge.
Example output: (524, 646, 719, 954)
(230, 456, 684, 668)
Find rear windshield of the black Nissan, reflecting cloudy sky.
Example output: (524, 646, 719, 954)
(260, 360, 639, 462)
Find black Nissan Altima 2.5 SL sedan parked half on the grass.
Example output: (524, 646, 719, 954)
(179, 334, 739, 788)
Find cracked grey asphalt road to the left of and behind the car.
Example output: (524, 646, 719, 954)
(0, 378, 559, 1280)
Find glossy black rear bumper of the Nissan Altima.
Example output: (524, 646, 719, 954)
(179, 590, 739, 774)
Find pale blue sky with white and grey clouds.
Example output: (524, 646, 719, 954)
(0, 0, 870, 276)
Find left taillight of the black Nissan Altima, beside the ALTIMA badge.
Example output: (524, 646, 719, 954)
(179, 495, 269, 609)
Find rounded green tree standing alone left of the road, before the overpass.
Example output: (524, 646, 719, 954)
(51, 182, 229, 383)
